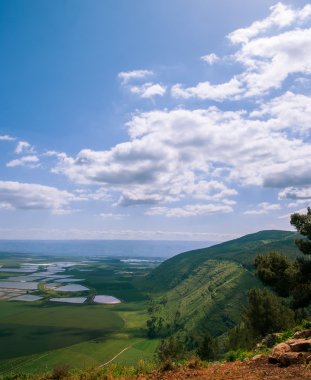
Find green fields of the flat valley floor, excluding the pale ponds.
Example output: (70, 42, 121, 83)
(0, 255, 158, 375)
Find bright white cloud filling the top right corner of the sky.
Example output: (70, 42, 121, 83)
(172, 3, 311, 101)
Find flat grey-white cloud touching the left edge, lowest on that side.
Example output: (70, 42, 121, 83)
(0, 181, 80, 213)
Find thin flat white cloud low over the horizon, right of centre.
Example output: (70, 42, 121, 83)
(146, 204, 233, 218)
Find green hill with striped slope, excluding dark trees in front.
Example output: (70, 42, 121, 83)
(141, 230, 299, 335)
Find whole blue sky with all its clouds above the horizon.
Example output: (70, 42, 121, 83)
(0, 0, 311, 241)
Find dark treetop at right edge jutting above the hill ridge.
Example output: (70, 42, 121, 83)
(290, 207, 311, 255)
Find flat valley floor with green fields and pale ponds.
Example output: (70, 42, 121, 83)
(0, 254, 161, 375)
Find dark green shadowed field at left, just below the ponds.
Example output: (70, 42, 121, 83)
(0, 301, 124, 359)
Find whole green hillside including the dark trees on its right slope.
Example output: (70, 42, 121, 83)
(143, 223, 310, 366)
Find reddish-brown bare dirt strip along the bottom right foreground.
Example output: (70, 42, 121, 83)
(138, 361, 311, 380)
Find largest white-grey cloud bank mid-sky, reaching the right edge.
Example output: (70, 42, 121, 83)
(53, 98, 311, 206)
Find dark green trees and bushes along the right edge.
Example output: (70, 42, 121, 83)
(224, 208, 311, 356)
